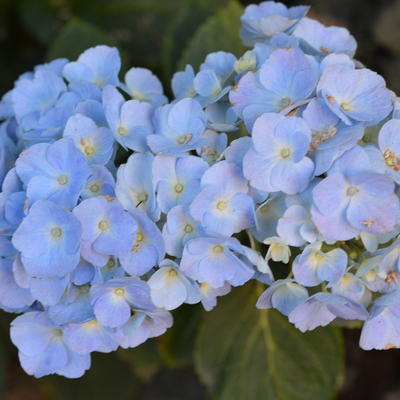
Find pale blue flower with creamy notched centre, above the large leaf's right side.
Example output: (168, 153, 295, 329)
(293, 242, 347, 286)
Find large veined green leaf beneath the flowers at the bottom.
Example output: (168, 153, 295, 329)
(195, 284, 344, 400)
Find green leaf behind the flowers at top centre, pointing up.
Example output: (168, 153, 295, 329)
(179, 0, 245, 69)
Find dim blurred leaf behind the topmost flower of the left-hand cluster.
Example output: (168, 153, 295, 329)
(47, 17, 115, 60)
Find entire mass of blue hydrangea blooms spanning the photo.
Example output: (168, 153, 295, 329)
(0, 1, 400, 378)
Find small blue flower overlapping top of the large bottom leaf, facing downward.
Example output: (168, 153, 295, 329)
(256, 279, 308, 315)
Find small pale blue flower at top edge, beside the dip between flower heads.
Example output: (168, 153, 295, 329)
(125, 68, 167, 107)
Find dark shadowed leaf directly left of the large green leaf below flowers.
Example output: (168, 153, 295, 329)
(158, 304, 204, 368)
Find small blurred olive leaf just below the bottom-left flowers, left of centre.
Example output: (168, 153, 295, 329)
(116, 339, 161, 381)
